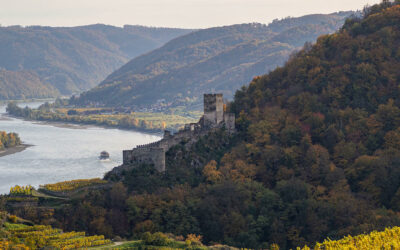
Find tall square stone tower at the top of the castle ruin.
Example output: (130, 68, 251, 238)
(204, 94, 224, 128)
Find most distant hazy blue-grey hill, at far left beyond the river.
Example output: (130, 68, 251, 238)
(0, 24, 191, 100)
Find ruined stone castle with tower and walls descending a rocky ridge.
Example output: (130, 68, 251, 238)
(123, 94, 235, 172)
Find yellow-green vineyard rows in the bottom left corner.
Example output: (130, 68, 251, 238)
(0, 222, 111, 249)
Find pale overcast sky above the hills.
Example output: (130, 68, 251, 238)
(0, 0, 380, 28)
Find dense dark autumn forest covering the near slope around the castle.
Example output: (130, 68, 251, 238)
(0, 1, 400, 249)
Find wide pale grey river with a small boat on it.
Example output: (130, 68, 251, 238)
(0, 103, 160, 194)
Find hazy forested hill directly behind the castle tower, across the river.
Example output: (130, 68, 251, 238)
(72, 12, 352, 108)
